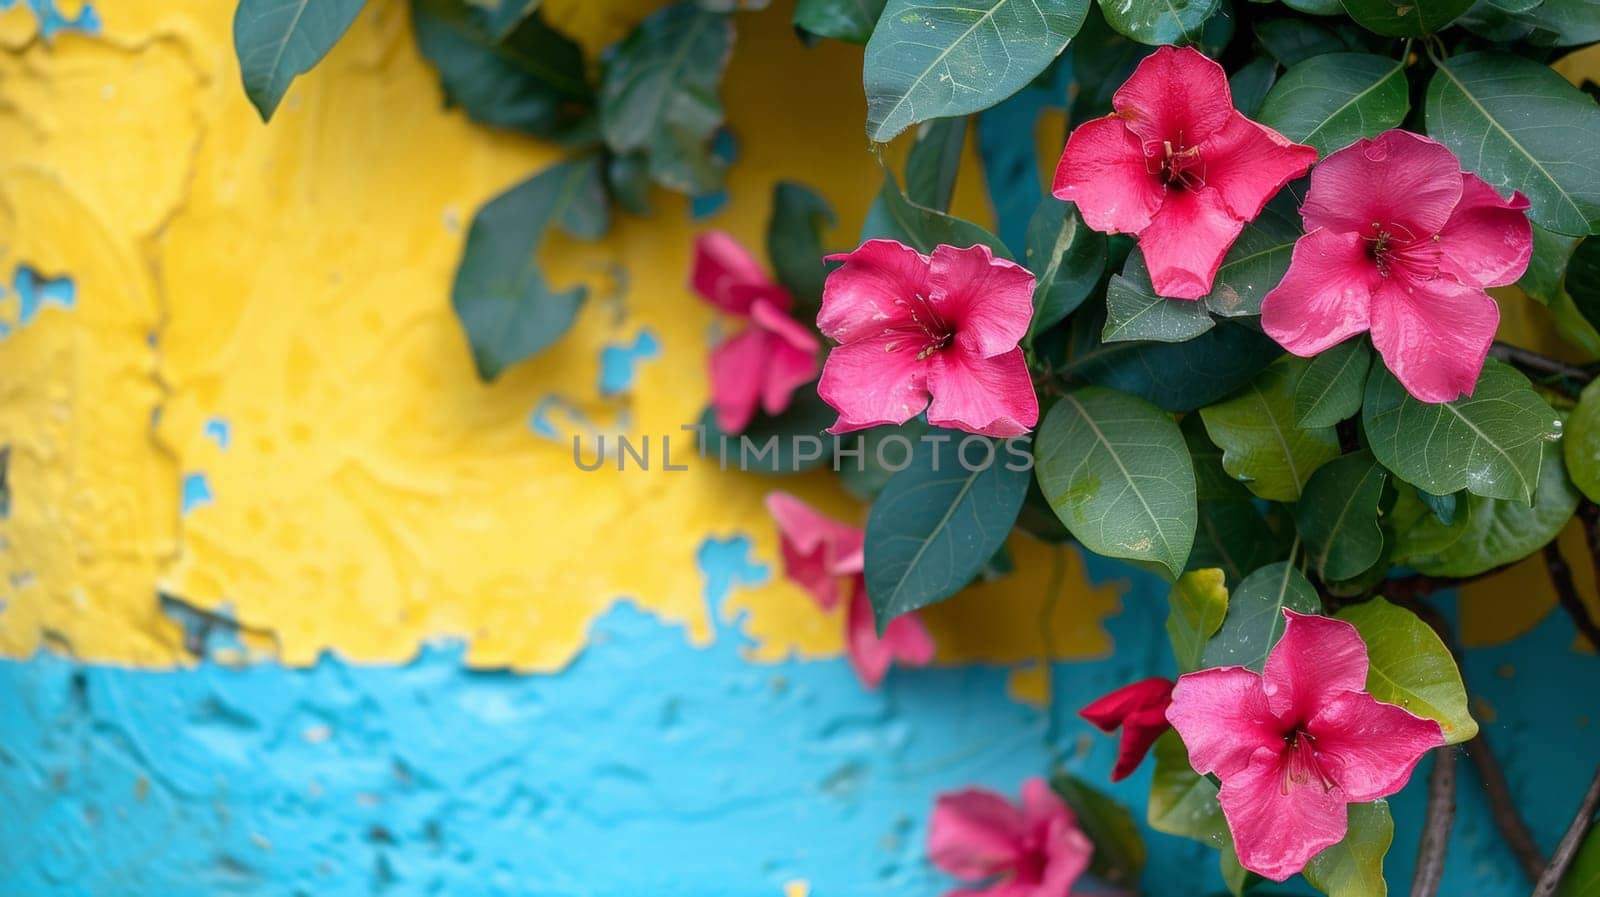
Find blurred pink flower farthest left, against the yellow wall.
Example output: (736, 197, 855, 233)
(690, 230, 821, 433)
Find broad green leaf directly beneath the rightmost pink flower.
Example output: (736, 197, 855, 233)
(1362, 358, 1558, 502)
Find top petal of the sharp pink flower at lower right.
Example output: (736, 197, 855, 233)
(1261, 609, 1366, 723)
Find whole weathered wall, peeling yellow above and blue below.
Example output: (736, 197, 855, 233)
(0, 0, 1600, 897)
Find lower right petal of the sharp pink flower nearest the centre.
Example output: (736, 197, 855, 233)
(928, 345, 1038, 438)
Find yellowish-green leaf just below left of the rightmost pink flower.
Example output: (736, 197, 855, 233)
(1200, 357, 1339, 502)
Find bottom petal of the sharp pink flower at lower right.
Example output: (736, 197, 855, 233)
(1218, 745, 1349, 881)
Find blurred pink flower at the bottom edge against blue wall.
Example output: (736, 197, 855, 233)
(928, 779, 1094, 897)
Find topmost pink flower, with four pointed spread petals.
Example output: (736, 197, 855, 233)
(1054, 46, 1317, 299)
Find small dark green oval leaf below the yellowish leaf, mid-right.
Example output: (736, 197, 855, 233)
(1294, 451, 1389, 582)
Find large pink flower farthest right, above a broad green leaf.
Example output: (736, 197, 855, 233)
(1261, 131, 1533, 401)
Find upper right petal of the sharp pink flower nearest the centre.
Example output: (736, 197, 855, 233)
(928, 245, 1035, 358)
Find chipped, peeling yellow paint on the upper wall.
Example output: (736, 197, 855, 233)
(0, 0, 1118, 670)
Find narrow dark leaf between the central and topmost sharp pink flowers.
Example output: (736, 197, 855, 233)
(1024, 197, 1106, 337)
